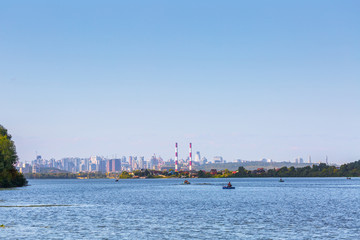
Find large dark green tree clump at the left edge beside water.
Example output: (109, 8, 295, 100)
(0, 125, 27, 188)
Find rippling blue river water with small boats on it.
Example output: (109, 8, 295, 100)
(0, 178, 360, 239)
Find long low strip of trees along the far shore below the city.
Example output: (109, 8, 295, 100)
(25, 160, 360, 179)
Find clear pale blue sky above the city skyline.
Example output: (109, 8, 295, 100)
(0, 0, 360, 164)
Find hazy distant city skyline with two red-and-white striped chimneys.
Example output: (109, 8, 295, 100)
(16, 143, 328, 173)
